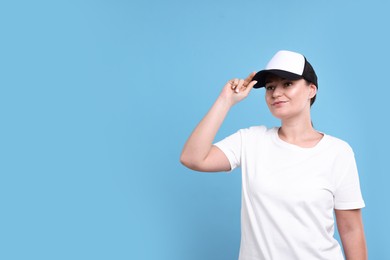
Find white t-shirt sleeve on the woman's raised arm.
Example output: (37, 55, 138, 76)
(214, 131, 242, 171)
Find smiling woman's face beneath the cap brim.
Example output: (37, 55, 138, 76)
(265, 75, 317, 120)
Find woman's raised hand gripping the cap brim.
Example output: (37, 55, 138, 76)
(219, 72, 257, 106)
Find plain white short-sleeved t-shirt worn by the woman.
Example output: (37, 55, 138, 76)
(215, 126, 365, 260)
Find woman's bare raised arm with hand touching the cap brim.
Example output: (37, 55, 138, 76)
(180, 72, 257, 172)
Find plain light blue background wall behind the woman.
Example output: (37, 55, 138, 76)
(0, 0, 390, 260)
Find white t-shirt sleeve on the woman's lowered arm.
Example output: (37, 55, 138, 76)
(334, 145, 365, 210)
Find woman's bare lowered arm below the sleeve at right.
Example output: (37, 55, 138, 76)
(335, 209, 368, 260)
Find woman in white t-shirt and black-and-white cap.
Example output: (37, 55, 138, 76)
(180, 51, 367, 260)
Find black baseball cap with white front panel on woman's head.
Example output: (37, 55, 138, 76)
(253, 50, 318, 89)
